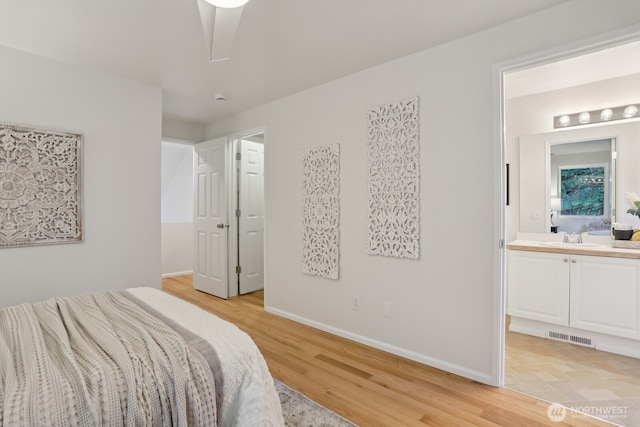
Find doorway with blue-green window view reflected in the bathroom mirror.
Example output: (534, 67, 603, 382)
(546, 138, 616, 235)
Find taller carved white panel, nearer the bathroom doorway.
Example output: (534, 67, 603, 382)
(368, 97, 420, 259)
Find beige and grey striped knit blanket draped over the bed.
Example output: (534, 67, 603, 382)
(0, 291, 219, 426)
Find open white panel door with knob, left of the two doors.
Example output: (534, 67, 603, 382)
(193, 138, 229, 299)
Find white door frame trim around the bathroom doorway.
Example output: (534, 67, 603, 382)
(492, 25, 640, 387)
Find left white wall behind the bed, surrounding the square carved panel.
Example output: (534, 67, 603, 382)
(0, 48, 162, 306)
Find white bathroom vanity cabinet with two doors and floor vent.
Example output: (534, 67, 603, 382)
(507, 242, 640, 357)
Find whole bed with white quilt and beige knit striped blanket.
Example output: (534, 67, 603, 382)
(0, 288, 284, 426)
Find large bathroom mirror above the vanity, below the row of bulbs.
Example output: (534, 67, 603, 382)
(513, 121, 640, 235)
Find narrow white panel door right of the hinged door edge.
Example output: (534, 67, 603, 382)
(238, 140, 264, 294)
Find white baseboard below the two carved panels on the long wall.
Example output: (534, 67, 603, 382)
(264, 306, 496, 386)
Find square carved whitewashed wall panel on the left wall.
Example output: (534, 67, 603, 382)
(0, 124, 82, 247)
